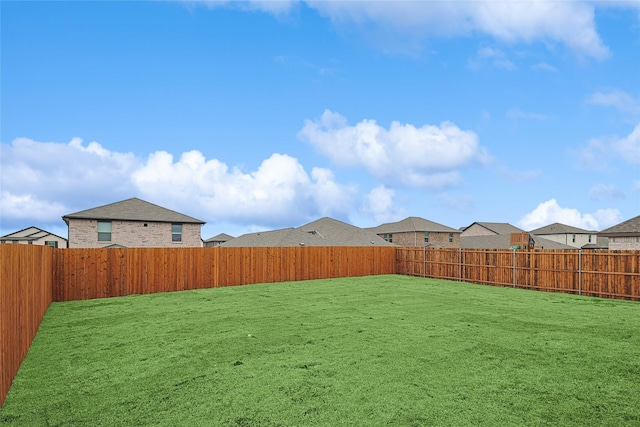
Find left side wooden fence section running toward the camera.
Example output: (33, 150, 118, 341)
(0, 244, 54, 407)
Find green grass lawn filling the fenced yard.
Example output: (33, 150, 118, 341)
(0, 276, 640, 426)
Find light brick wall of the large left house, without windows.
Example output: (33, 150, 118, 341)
(69, 219, 202, 248)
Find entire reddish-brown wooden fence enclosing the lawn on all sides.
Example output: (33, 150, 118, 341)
(0, 244, 640, 406)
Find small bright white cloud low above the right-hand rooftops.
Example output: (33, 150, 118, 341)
(518, 199, 622, 230)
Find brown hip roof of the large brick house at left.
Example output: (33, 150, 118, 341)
(62, 197, 204, 224)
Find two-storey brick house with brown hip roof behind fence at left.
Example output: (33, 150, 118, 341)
(62, 197, 204, 248)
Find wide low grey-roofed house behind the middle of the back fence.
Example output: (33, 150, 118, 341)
(220, 217, 393, 247)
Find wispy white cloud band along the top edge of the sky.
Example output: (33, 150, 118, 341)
(177, 0, 616, 59)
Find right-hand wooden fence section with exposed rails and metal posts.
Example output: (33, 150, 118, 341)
(396, 248, 640, 300)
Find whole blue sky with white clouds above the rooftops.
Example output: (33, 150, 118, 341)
(0, 0, 640, 239)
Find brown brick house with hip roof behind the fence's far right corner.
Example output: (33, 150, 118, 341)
(367, 216, 461, 248)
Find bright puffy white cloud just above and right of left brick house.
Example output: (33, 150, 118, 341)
(132, 151, 353, 225)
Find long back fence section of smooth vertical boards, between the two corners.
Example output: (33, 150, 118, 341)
(53, 246, 396, 301)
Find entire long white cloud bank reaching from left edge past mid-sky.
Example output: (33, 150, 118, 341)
(0, 138, 357, 228)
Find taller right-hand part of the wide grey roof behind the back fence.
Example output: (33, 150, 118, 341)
(298, 217, 394, 246)
